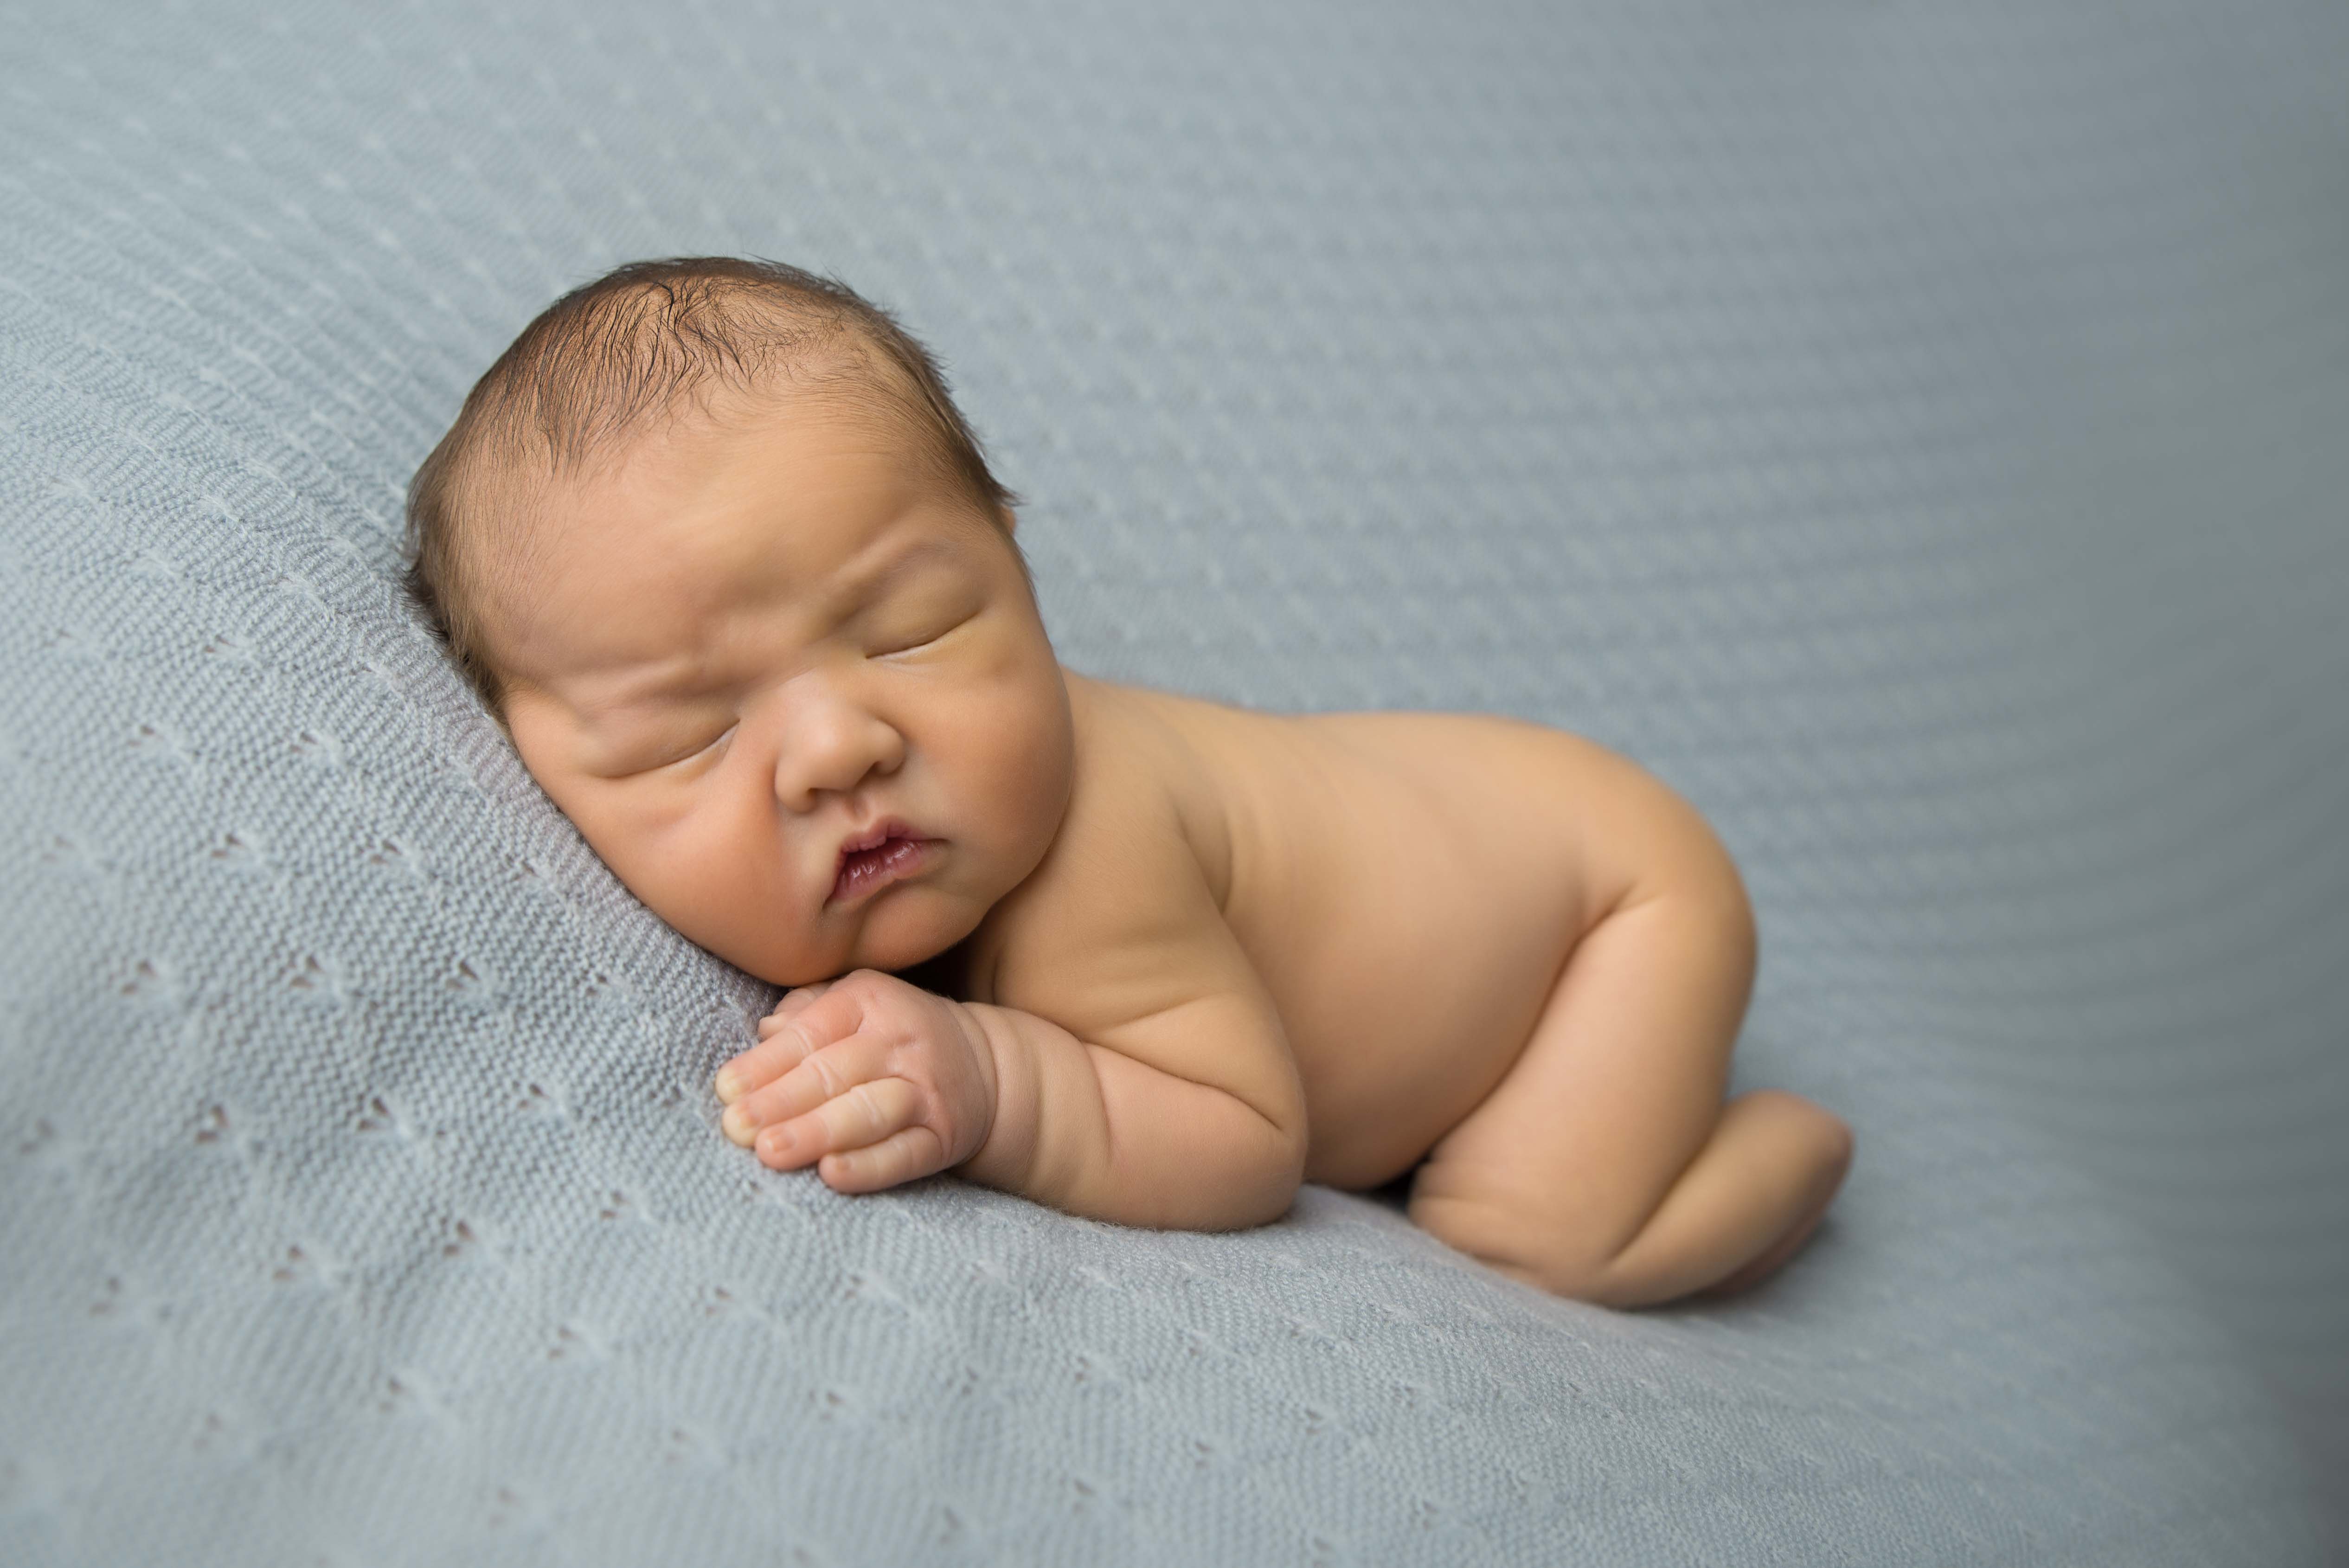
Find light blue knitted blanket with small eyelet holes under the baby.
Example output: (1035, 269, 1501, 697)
(0, 0, 2349, 1568)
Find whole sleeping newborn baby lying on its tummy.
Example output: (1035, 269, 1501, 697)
(409, 258, 1851, 1307)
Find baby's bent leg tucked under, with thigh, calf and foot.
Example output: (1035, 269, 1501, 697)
(1409, 891, 1848, 1307)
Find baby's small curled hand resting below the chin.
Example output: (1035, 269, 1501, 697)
(717, 969, 996, 1192)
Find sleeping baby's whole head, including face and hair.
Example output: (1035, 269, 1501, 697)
(409, 258, 1073, 985)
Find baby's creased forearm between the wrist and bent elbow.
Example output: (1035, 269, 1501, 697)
(961, 1002, 1304, 1229)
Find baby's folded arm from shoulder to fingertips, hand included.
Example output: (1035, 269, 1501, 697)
(719, 809, 1306, 1229)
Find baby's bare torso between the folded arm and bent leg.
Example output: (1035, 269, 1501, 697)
(935, 672, 1607, 1187)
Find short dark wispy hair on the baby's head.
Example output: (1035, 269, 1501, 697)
(406, 256, 1027, 712)
